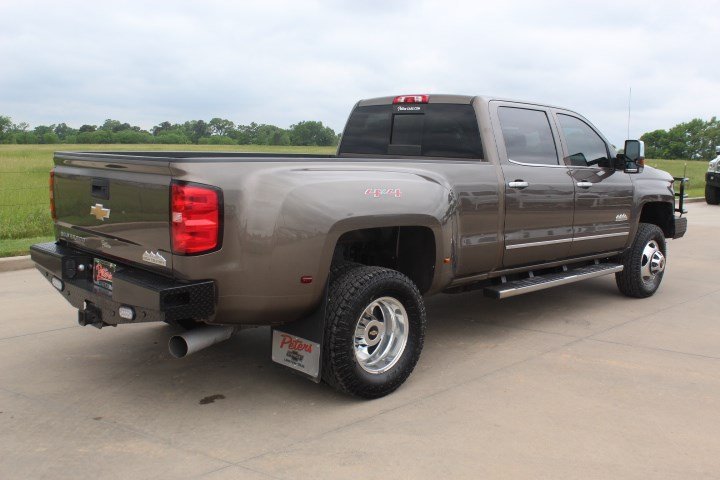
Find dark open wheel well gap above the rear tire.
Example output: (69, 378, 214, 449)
(333, 227, 436, 293)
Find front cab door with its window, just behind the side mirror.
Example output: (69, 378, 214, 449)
(554, 110, 633, 256)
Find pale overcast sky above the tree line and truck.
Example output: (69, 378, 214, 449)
(0, 0, 720, 145)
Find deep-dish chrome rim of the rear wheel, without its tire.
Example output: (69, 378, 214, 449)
(353, 297, 409, 374)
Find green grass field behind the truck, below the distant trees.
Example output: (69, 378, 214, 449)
(0, 145, 707, 257)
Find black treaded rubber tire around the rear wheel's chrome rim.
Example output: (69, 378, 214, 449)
(323, 266, 426, 398)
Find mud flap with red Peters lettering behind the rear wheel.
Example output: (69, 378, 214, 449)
(272, 286, 328, 383)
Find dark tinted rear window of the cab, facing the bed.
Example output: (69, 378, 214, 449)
(340, 103, 483, 158)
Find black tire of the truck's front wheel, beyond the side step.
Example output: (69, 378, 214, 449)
(615, 223, 667, 298)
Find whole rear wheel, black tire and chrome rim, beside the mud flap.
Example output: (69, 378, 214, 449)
(323, 267, 426, 398)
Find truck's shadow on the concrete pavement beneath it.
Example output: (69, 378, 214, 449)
(71, 279, 626, 409)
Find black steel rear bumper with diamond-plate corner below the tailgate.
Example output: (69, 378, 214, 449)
(30, 243, 216, 327)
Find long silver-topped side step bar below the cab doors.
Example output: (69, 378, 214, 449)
(483, 263, 623, 299)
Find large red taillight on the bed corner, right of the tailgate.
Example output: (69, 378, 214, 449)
(170, 183, 222, 255)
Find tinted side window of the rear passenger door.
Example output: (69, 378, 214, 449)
(498, 107, 558, 165)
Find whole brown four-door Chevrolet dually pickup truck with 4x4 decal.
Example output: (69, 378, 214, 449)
(31, 95, 687, 398)
